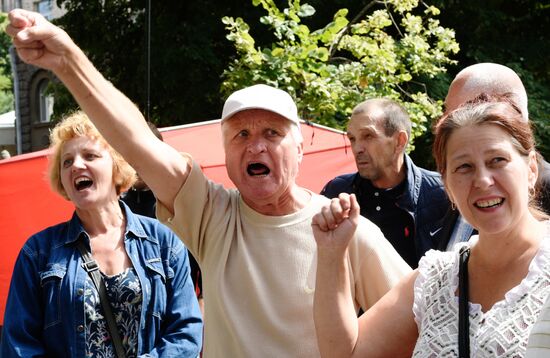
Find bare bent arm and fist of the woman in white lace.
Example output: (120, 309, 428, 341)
(312, 194, 418, 357)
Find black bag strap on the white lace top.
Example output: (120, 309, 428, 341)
(458, 246, 470, 358)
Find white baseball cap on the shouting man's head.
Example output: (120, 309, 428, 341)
(222, 84, 300, 126)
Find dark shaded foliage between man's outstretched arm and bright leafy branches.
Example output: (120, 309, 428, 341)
(54, 0, 268, 126)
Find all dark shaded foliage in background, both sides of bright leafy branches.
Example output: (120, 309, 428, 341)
(44, 0, 550, 162)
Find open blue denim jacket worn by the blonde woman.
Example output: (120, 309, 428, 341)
(1, 202, 202, 358)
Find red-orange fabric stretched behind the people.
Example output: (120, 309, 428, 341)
(0, 121, 356, 325)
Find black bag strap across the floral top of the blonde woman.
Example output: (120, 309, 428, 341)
(76, 240, 126, 358)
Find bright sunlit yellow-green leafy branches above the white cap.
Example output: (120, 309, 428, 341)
(222, 0, 458, 145)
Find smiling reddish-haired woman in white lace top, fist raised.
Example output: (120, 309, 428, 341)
(312, 95, 550, 358)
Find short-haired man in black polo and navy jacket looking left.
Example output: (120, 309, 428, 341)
(321, 99, 449, 268)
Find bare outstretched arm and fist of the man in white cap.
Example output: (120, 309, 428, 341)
(6, 9, 191, 212)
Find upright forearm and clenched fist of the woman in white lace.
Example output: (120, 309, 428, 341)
(311, 194, 359, 357)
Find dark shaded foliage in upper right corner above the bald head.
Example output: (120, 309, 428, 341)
(432, 0, 550, 159)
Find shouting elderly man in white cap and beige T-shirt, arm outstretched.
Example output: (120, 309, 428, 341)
(7, 10, 410, 357)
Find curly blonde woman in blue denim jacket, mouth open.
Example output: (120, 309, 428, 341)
(1, 112, 202, 358)
